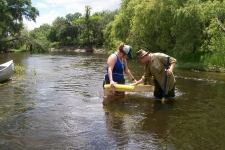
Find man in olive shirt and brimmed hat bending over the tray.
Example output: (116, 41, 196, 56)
(133, 49, 177, 98)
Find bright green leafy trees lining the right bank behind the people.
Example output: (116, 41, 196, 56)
(104, 0, 225, 70)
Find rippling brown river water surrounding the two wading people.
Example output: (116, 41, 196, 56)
(0, 52, 225, 150)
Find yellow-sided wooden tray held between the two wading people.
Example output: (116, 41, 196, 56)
(104, 84, 155, 92)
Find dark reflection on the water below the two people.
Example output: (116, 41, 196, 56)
(104, 95, 175, 149)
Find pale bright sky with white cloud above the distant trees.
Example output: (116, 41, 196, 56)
(24, 0, 121, 30)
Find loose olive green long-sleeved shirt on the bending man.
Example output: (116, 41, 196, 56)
(142, 53, 177, 94)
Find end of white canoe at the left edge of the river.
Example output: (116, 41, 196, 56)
(0, 60, 14, 82)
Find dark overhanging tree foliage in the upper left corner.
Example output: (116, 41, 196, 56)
(0, 0, 39, 51)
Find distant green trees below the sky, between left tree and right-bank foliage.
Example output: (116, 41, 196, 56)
(24, 6, 118, 50)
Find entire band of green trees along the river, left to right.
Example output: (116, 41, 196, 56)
(0, 0, 225, 72)
